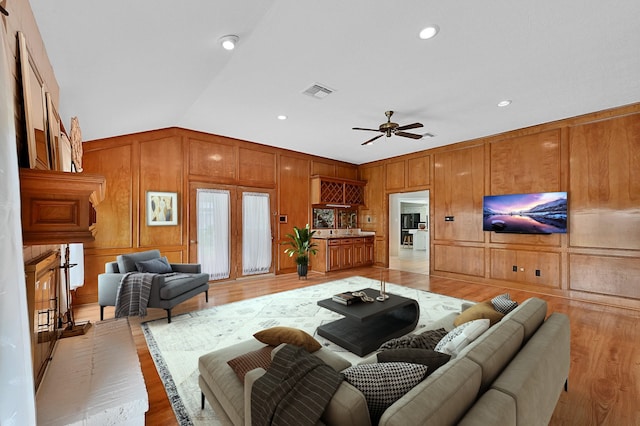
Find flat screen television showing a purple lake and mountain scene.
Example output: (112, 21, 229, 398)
(482, 192, 567, 234)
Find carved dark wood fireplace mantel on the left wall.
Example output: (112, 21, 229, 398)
(20, 169, 105, 245)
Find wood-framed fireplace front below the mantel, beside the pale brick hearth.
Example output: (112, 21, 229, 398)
(25, 251, 60, 389)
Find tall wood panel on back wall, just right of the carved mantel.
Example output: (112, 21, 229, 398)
(83, 144, 137, 249)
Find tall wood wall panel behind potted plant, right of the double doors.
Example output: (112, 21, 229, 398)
(276, 154, 312, 272)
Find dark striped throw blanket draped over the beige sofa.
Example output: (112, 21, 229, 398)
(251, 345, 344, 426)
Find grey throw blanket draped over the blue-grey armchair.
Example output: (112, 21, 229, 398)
(115, 272, 157, 318)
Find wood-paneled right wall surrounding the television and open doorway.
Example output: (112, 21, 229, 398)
(359, 104, 640, 309)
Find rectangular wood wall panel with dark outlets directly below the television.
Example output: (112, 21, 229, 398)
(491, 249, 560, 288)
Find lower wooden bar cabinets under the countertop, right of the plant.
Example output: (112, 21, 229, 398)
(311, 237, 373, 272)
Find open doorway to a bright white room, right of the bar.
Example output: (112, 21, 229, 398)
(389, 191, 431, 275)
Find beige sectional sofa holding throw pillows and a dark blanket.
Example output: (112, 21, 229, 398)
(199, 298, 570, 426)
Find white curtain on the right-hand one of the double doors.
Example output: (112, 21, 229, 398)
(242, 192, 271, 275)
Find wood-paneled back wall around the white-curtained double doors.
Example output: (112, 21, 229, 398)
(75, 128, 357, 304)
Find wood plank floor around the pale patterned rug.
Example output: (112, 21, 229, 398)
(75, 267, 640, 426)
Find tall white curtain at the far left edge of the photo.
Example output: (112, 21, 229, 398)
(0, 19, 36, 425)
